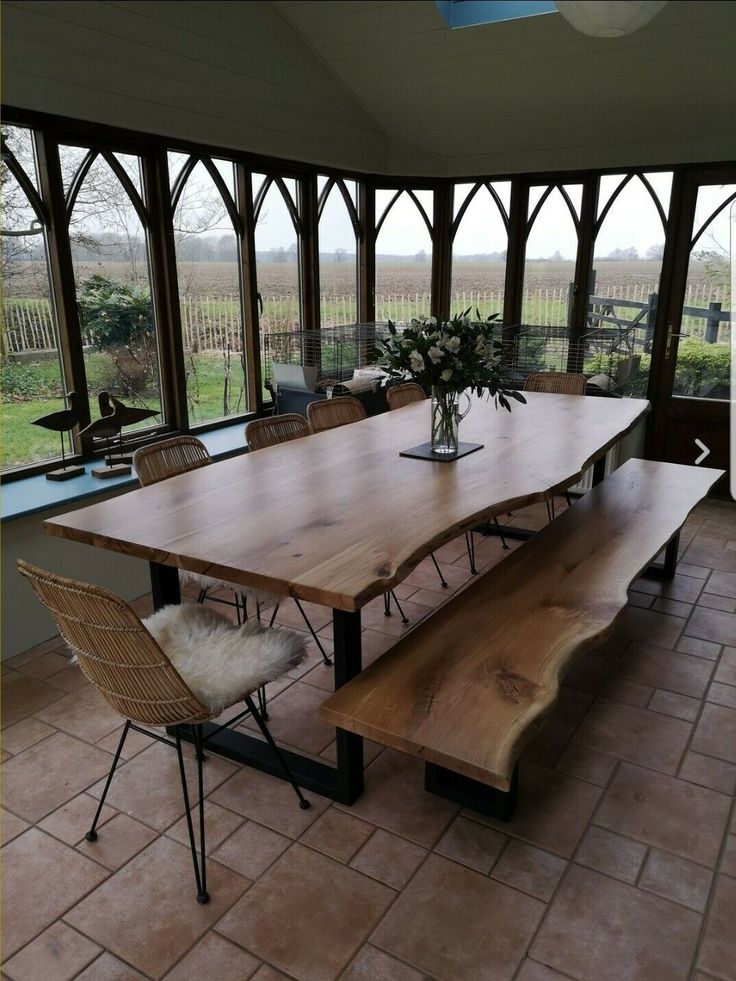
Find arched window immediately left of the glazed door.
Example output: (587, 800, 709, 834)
(587, 172, 672, 396)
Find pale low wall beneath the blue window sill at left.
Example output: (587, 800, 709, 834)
(0, 495, 151, 660)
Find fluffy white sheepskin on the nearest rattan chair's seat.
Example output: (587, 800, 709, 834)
(143, 603, 306, 715)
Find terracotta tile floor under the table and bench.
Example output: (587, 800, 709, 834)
(2, 501, 736, 981)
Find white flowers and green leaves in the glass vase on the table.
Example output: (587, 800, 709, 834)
(376, 310, 526, 412)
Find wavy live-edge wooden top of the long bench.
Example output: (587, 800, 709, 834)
(320, 460, 722, 791)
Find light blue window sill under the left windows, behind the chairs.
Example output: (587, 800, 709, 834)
(0, 422, 245, 522)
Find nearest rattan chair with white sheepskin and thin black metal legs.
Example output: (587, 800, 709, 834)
(18, 560, 309, 903)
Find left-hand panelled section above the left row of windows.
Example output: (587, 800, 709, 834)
(2, 0, 386, 171)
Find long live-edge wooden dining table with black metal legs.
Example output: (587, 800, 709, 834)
(45, 393, 649, 804)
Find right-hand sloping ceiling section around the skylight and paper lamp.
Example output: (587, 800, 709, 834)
(272, 0, 736, 175)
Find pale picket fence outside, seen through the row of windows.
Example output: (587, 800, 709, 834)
(1, 282, 731, 355)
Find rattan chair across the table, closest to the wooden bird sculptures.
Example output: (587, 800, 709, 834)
(133, 436, 261, 622)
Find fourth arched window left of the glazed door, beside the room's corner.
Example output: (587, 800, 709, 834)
(375, 189, 433, 321)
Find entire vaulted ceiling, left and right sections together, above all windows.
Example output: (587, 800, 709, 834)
(2, 0, 736, 176)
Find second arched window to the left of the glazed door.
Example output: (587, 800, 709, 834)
(521, 184, 582, 327)
